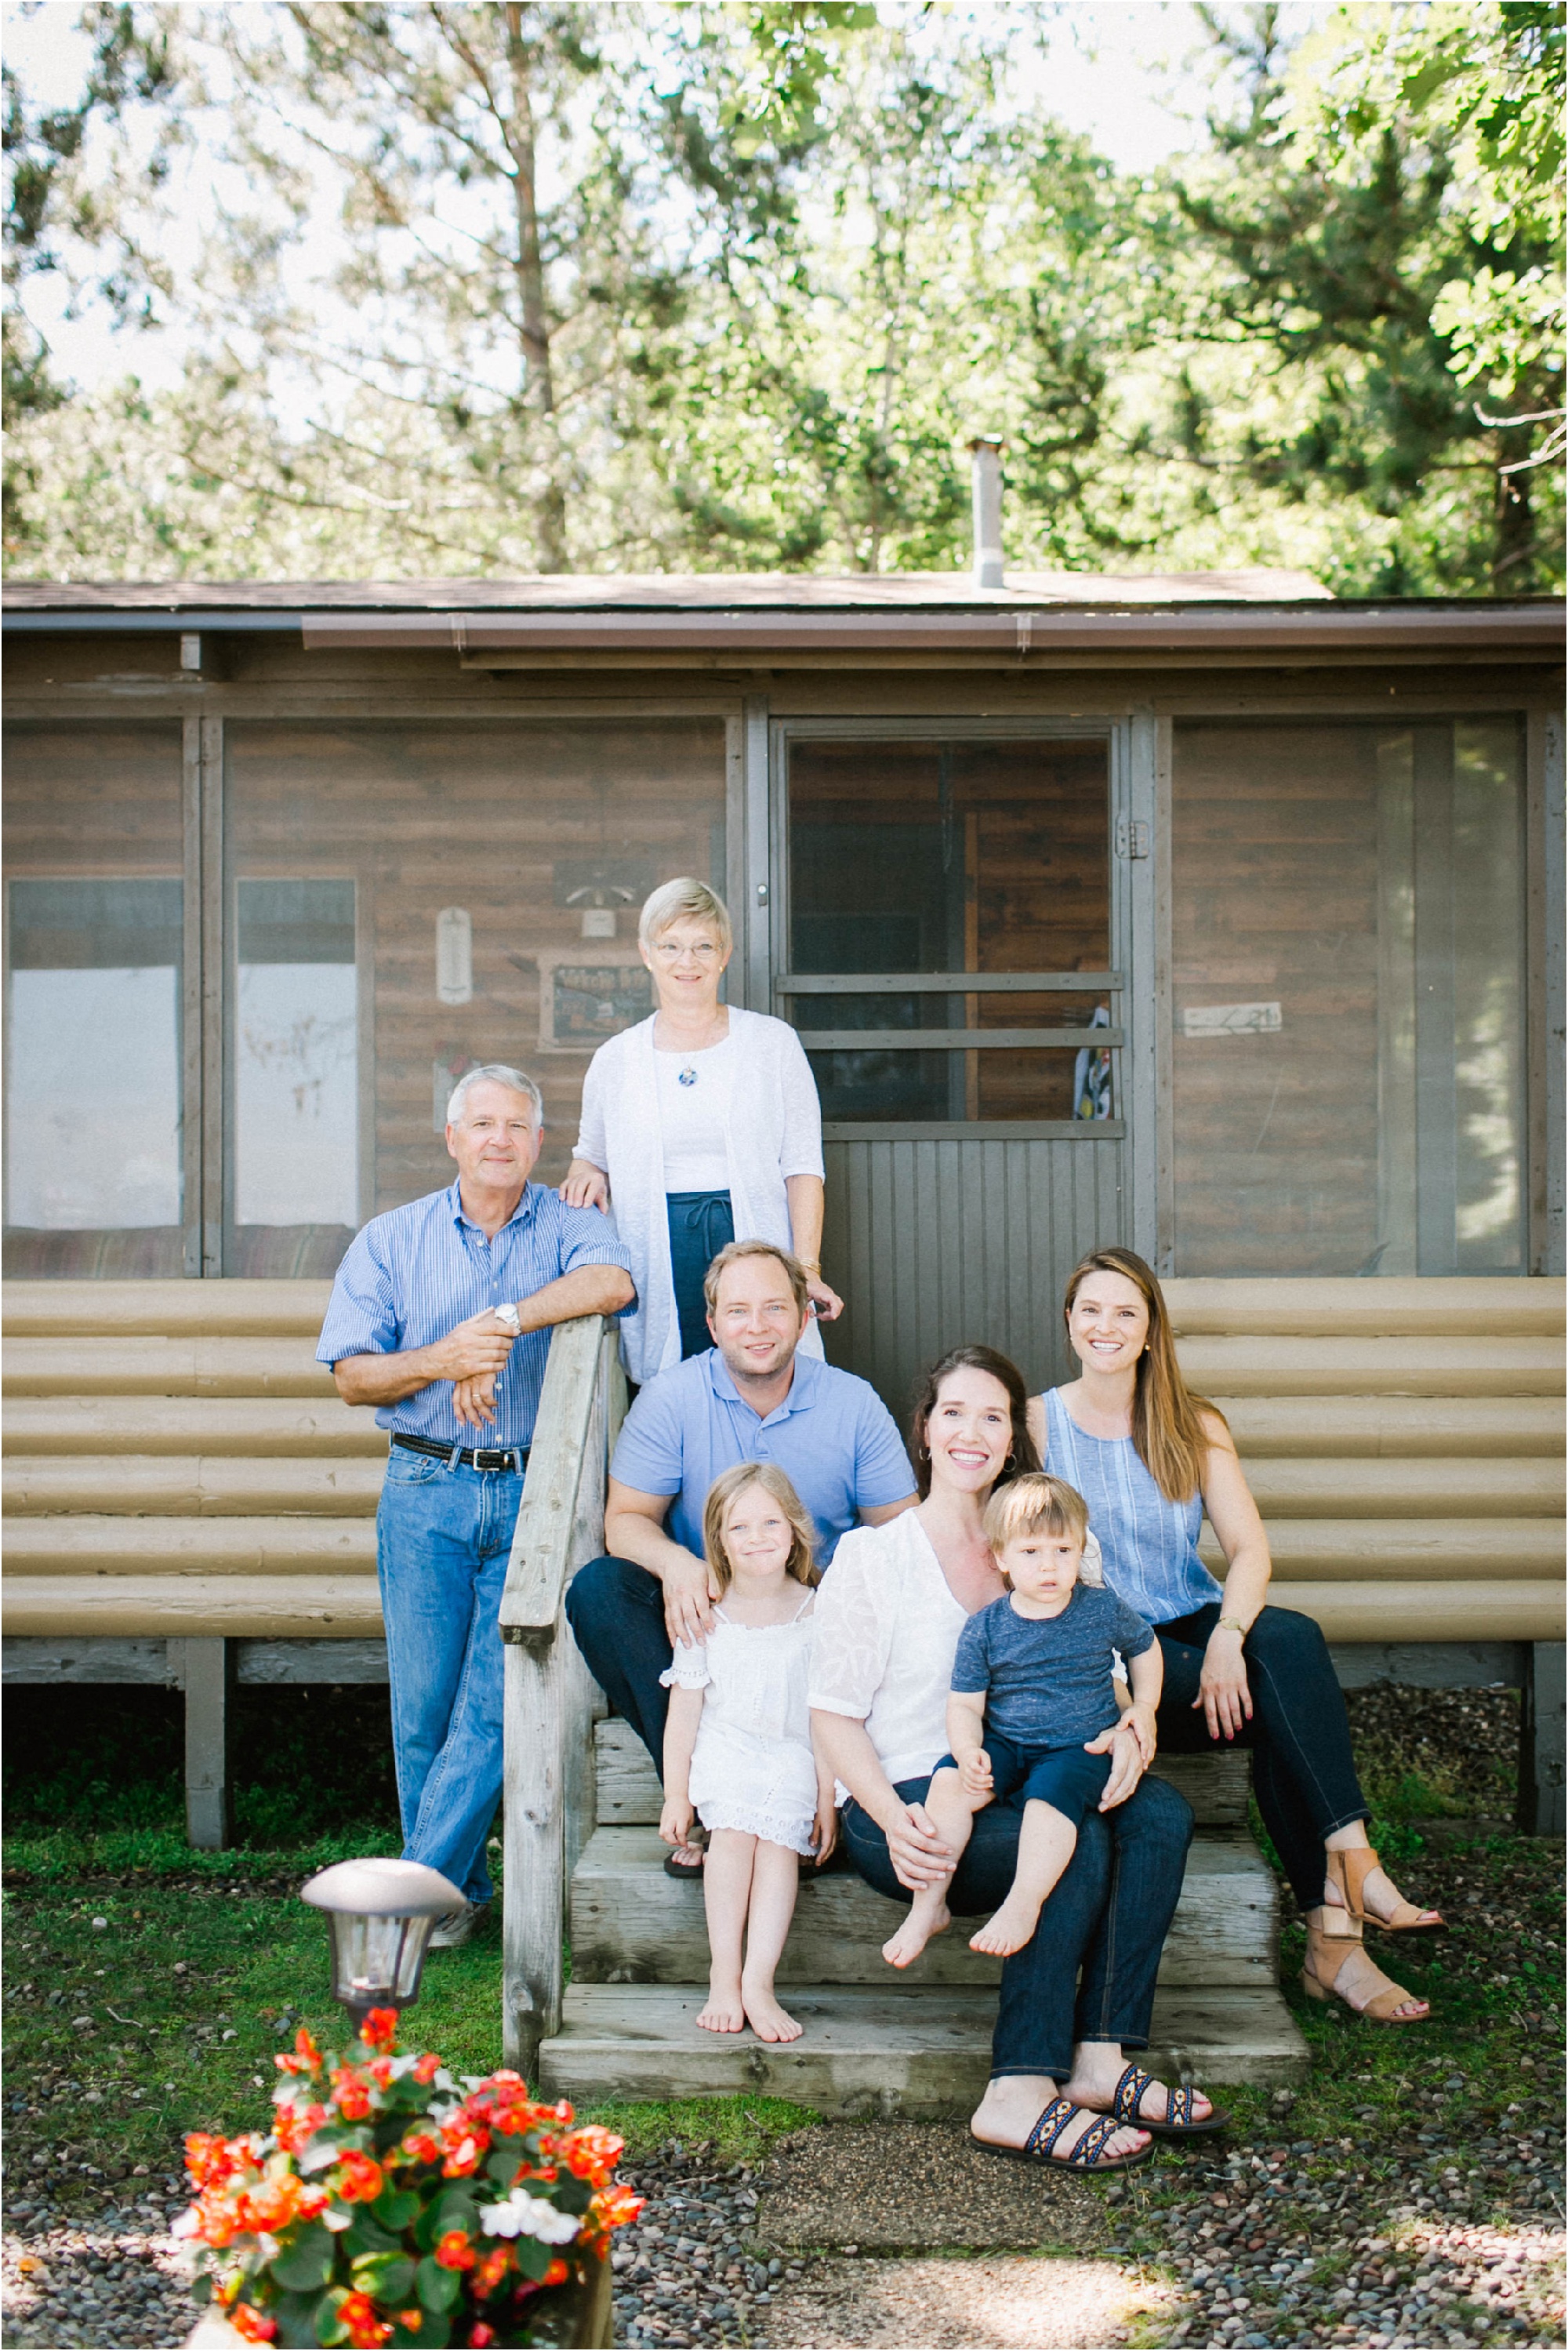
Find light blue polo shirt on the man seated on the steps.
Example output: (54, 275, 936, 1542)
(609, 1347, 914, 1568)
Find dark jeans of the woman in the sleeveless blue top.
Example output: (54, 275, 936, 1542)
(1154, 1601, 1366, 1911)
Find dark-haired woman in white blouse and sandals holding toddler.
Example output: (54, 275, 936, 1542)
(811, 1347, 1220, 2170)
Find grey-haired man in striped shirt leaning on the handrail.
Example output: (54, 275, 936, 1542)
(315, 1063, 635, 1946)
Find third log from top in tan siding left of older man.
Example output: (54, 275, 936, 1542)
(5, 1394, 388, 1460)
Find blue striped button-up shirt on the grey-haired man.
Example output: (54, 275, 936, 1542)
(315, 1183, 630, 1446)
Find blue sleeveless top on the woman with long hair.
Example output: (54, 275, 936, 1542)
(1046, 1387, 1220, 1625)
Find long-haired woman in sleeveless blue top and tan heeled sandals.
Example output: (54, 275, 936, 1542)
(1029, 1248, 1443, 2024)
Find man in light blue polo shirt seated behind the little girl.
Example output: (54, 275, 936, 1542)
(567, 1241, 916, 1876)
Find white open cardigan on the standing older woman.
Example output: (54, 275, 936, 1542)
(576, 1004, 822, 1385)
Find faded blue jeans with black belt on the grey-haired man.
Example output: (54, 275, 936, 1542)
(376, 1446, 522, 1902)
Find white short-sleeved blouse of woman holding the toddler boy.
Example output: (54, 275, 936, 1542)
(811, 1510, 968, 1786)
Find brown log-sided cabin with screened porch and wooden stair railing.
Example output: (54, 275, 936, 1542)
(5, 574, 1563, 2106)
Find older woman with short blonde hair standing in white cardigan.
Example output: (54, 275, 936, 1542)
(562, 879, 841, 1383)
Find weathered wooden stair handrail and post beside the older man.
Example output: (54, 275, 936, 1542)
(501, 1314, 626, 2076)
